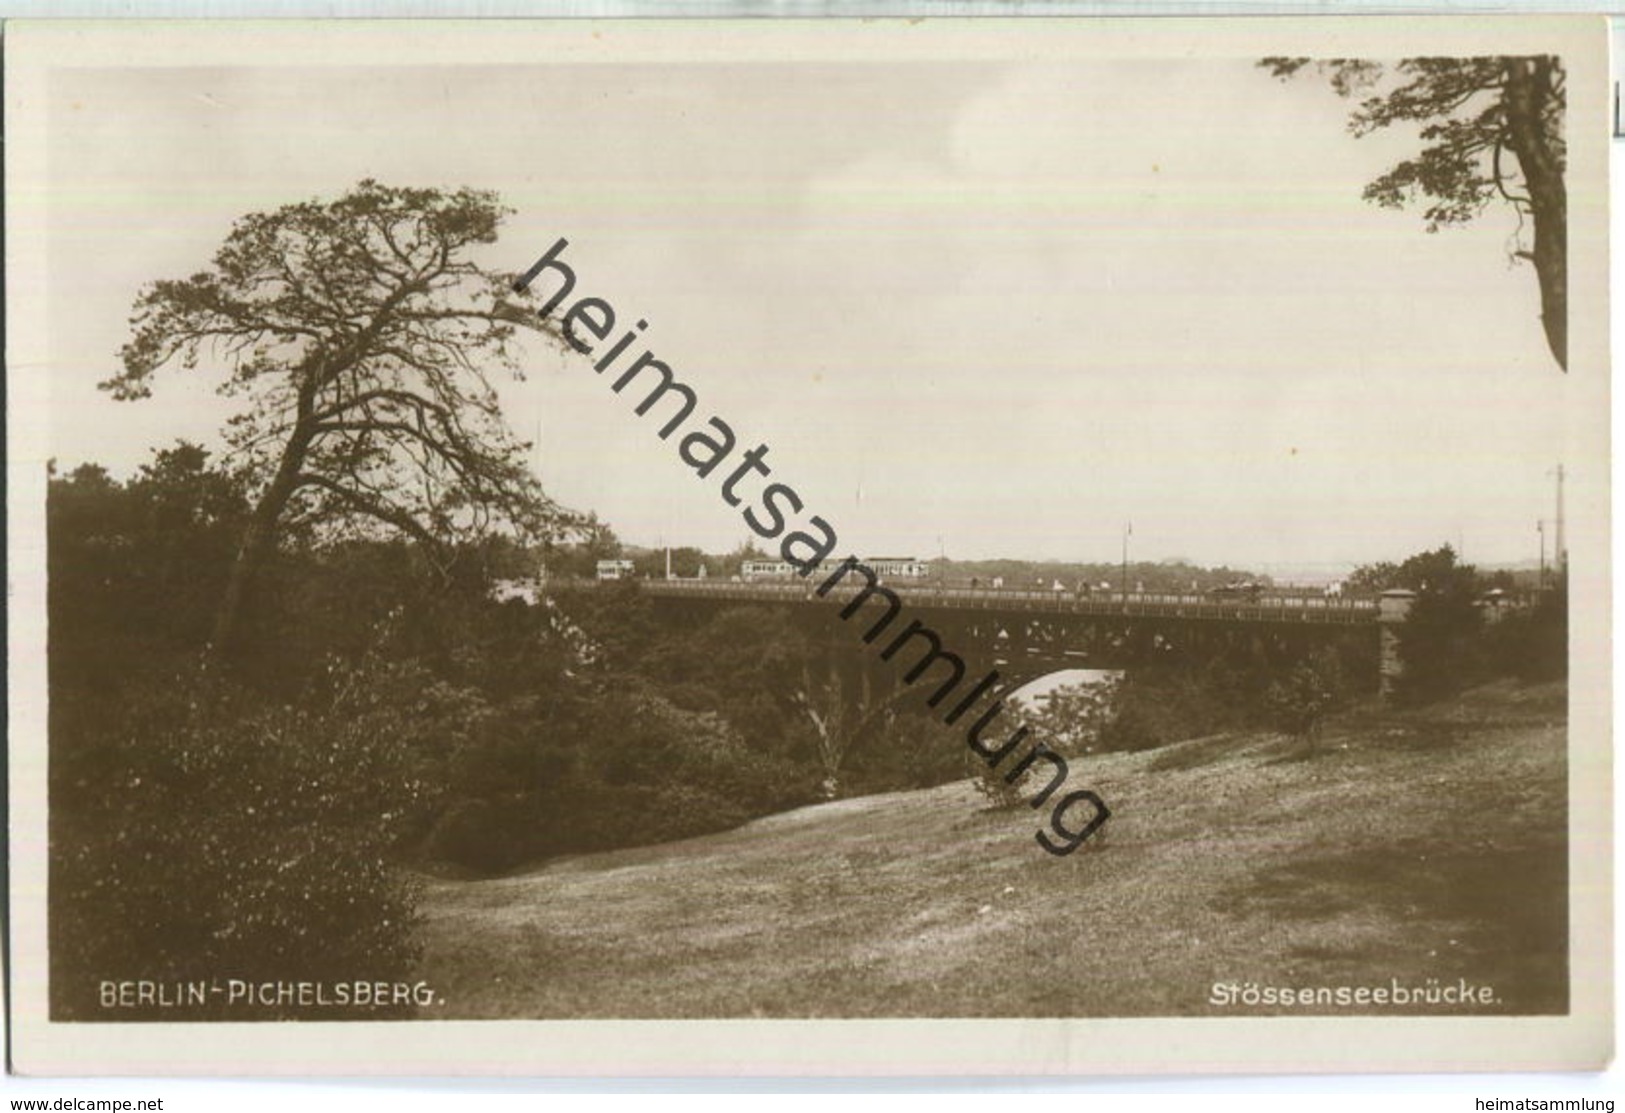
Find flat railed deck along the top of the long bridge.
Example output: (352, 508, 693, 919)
(570, 580, 1376, 626)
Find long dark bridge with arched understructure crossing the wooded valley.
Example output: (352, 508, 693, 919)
(549, 577, 1393, 687)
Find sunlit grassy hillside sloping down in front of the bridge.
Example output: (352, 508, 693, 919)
(424, 684, 1568, 1017)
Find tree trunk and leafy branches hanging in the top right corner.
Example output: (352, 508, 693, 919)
(1259, 55, 1568, 370)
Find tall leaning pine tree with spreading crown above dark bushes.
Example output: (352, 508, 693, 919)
(101, 180, 569, 652)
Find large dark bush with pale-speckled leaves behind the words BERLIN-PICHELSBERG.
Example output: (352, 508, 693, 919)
(50, 659, 418, 1020)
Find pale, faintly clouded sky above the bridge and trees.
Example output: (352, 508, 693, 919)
(46, 36, 1586, 575)
